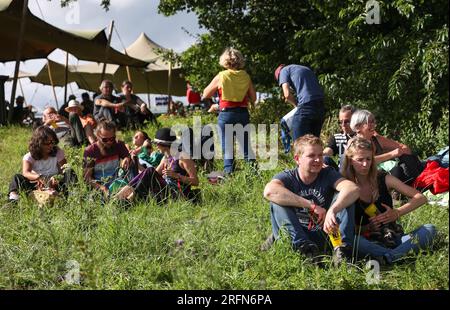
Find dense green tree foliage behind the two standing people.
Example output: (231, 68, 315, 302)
(159, 0, 448, 154)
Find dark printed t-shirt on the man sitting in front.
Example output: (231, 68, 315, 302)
(273, 167, 342, 230)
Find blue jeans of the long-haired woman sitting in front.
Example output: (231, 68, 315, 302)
(356, 224, 436, 263)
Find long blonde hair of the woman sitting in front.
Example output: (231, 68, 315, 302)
(342, 137, 379, 202)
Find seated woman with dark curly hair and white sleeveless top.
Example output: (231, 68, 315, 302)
(9, 126, 76, 202)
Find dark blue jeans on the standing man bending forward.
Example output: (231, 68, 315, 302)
(292, 100, 325, 141)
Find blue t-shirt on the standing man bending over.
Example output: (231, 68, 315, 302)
(278, 65, 324, 105)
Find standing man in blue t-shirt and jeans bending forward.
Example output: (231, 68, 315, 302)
(275, 64, 325, 141)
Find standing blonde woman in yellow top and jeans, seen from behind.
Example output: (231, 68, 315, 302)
(203, 47, 256, 174)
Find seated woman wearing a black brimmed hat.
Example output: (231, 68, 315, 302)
(117, 128, 199, 202)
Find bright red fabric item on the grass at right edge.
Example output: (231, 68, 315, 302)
(413, 160, 449, 195)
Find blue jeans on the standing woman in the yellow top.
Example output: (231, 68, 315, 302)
(218, 108, 255, 173)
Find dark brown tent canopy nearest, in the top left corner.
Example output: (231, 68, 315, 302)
(0, 0, 147, 67)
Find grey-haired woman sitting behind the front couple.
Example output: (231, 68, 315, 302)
(350, 110, 424, 185)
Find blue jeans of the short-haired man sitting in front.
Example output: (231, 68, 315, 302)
(270, 195, 355, 251)
